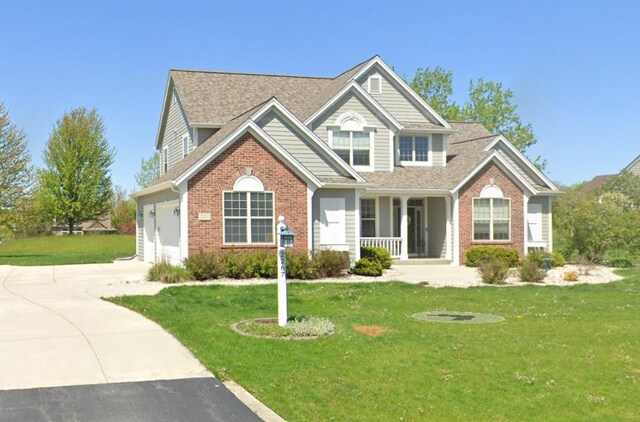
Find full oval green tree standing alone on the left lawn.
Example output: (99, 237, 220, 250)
(39, 107, 115, 234)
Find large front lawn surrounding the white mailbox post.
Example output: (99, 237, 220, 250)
(112, 270, 640, 421)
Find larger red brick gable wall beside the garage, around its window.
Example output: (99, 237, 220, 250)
(188, 133, 307, 254)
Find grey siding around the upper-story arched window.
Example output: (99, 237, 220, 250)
(311, 94, 391, 171)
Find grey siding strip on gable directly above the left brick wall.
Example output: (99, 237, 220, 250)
(259, 111, 347, 177)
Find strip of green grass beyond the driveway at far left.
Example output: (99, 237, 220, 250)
(0, 235, 136, 265)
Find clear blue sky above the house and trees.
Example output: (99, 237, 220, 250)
(0, 0, 640, 189)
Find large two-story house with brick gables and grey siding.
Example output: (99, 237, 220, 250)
(134, 56, 560, 264)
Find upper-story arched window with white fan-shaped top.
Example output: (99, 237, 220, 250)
(329, 112, 373, 170)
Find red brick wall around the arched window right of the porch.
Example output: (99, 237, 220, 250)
(459, 163, 524, 264)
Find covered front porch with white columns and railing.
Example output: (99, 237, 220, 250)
(360, 194, 453, 260)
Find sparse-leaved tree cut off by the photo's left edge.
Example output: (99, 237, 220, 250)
(0, 103, 33, 211)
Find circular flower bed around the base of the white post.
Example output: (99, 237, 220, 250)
(231, 317, 335, 340)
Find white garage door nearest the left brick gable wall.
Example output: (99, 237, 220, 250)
(156, 201, 180, 264)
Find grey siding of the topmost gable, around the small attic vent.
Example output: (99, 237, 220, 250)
(358, 67, 438, 124)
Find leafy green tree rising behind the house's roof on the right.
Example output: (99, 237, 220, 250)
(410, 66, 546, 169)
